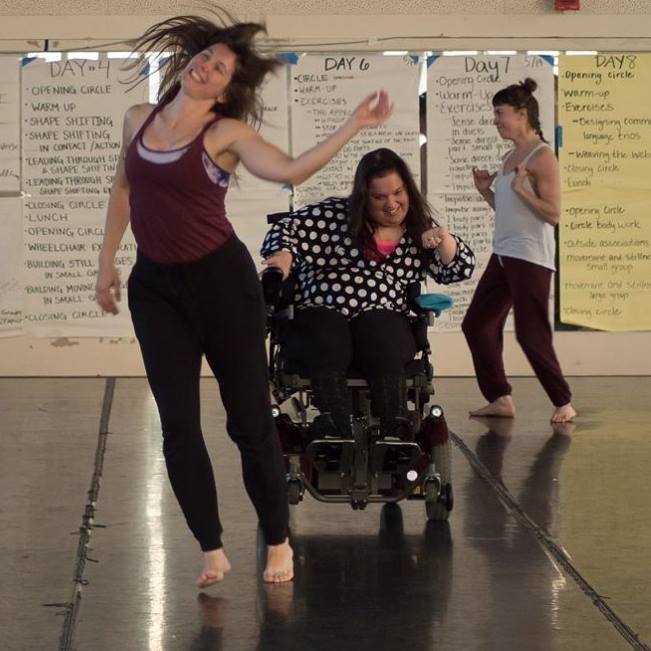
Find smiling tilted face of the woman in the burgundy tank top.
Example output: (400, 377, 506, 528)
(181, 43, 237, 101)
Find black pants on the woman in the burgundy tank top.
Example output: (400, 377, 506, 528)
(128, 235, 289, 551)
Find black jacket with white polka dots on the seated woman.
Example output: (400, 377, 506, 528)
(261, 197, 475, 318)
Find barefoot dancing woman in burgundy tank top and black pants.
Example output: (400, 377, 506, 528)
(96, 10, 392, 587)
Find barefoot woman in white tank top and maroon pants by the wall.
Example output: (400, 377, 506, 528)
(462, 79, 576, 423)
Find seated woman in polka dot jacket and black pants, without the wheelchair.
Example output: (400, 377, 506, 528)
(262, 148, 475, 440)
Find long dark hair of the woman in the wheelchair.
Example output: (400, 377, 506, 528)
(348, 147, 437, 253)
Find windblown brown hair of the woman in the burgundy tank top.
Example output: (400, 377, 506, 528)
(125, 8, 280, 124)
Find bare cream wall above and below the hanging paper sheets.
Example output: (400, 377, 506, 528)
(0, 0, 651, 376)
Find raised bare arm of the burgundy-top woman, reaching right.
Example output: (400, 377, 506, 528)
(228, 91, 393, 185)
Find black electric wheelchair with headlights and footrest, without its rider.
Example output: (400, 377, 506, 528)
(262, 213, 453, 520)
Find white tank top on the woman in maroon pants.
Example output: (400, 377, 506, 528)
(493, 142, 556, 271)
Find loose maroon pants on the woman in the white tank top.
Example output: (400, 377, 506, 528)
(461, 254, 572, 407)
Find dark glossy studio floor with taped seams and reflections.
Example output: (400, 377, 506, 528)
(0, 378, 651, 651)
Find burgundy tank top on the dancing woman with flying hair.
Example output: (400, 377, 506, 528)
(125, 106, 233, 263)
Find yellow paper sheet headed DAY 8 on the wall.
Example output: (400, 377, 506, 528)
(558, 53, 651, 331)
